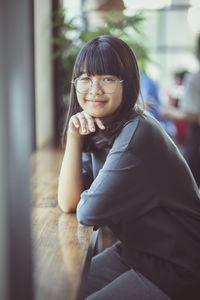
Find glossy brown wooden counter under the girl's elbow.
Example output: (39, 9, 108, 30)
(31, 149, 97, 300)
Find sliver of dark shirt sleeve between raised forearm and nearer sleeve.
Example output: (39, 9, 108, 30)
(82, 152, 93, 190)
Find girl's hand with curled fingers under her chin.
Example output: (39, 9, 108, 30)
(68, 111, 105, 136)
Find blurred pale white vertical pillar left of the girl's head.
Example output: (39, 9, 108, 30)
(34, 0, 53, 148)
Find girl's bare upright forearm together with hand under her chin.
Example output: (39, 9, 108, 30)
(58, 111, 105, 213)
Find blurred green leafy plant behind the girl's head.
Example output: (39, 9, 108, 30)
(53, 9, 149, 98)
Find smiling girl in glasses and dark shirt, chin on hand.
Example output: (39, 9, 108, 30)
(58, 36, 200, 300)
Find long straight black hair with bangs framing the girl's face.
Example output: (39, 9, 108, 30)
(63, 35, 140, 152)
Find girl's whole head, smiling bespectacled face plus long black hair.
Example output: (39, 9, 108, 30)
(63, 36, 139, 150)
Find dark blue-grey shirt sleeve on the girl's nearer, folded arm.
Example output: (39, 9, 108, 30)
(77, 149, 156, 228)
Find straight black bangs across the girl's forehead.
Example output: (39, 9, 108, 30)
(74, 43, 124, 79)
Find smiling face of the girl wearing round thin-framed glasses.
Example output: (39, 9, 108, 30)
(76, 73, 123, 118)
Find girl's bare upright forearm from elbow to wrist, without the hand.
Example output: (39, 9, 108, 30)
(58, 132, 84, 213)
